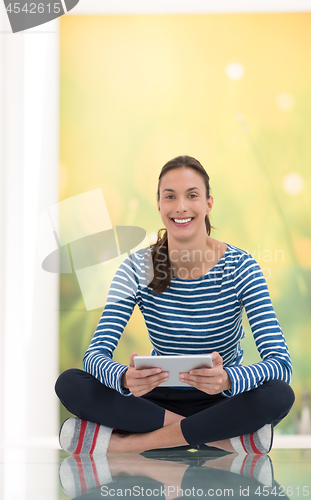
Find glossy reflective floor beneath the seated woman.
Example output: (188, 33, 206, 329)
(0, 447, 311, 500)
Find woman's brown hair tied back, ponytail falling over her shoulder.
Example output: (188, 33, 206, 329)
(148, 156, 213, 294)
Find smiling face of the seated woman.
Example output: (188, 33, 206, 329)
(157, 167, 213, 240)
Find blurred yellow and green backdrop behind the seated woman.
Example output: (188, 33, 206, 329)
(59, 13, 311, 434)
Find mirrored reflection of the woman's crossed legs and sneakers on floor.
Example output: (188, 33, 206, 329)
(59, 447, 292, 500)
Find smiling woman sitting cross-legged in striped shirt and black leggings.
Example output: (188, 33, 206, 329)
(55, 156, 294, 453)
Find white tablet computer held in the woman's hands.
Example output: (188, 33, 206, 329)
(134, 354, 213, 387)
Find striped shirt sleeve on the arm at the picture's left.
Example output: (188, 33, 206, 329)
(83, 257, 138, 395)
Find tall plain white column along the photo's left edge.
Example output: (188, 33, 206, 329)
(0, 6, 59, 447)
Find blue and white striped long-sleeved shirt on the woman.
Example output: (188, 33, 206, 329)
(83, 243, 292, 397)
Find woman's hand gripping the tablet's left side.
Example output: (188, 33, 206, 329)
(121, 352, 168, 397)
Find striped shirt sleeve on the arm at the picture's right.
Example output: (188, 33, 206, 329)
(223, 253, 292, 396)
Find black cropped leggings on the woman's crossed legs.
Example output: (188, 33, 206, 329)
(55, 368, 295, 446)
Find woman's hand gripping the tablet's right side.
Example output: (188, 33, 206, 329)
(179, 351, 231, 395)
